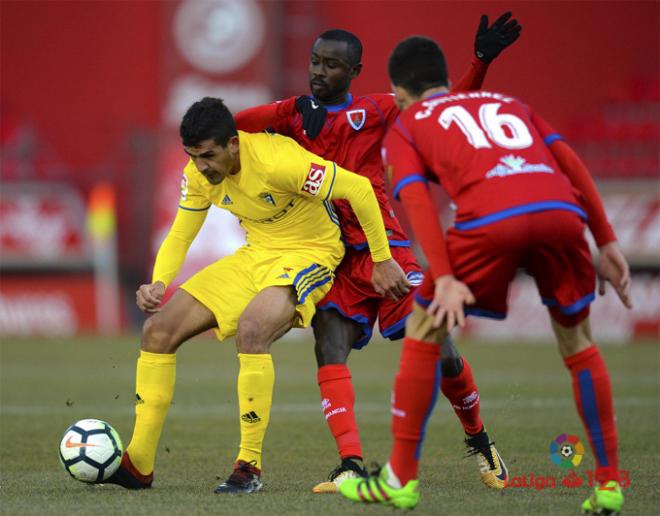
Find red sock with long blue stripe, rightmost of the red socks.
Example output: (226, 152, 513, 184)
(564, 345, 619, 482)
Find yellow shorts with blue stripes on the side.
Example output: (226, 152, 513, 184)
(181, 246, 334, 340)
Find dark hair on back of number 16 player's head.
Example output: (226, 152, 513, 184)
(387, 36, 448, 95)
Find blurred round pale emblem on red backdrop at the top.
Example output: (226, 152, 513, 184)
(178, 0, 264, 73)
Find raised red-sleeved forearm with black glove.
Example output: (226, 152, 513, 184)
(452, 11, 522, 91)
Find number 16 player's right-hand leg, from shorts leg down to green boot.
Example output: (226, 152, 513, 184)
(526, 211, 623, 512)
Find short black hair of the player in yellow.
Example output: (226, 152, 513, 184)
(179, 97, 238, 147)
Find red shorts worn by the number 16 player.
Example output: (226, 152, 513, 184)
(415, 210, 596, 327)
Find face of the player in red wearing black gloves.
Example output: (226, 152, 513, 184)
(309, 39, 362, 105)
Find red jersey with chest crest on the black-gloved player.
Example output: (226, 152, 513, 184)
(236, 94, 409, 249)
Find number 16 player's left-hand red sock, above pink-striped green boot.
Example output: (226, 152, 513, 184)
(390, 337, 440, 485)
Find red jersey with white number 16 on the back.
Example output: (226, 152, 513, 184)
(384, 91, 586, 230)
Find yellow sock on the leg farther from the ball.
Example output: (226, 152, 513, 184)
(236, 353, 275, 469)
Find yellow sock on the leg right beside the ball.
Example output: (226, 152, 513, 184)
(126, 351, 176, 475)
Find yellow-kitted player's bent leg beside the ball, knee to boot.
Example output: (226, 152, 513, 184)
(108, 289, 217, 489)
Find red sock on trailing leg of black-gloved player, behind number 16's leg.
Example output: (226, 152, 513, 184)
(440, 357, 484, 435)
